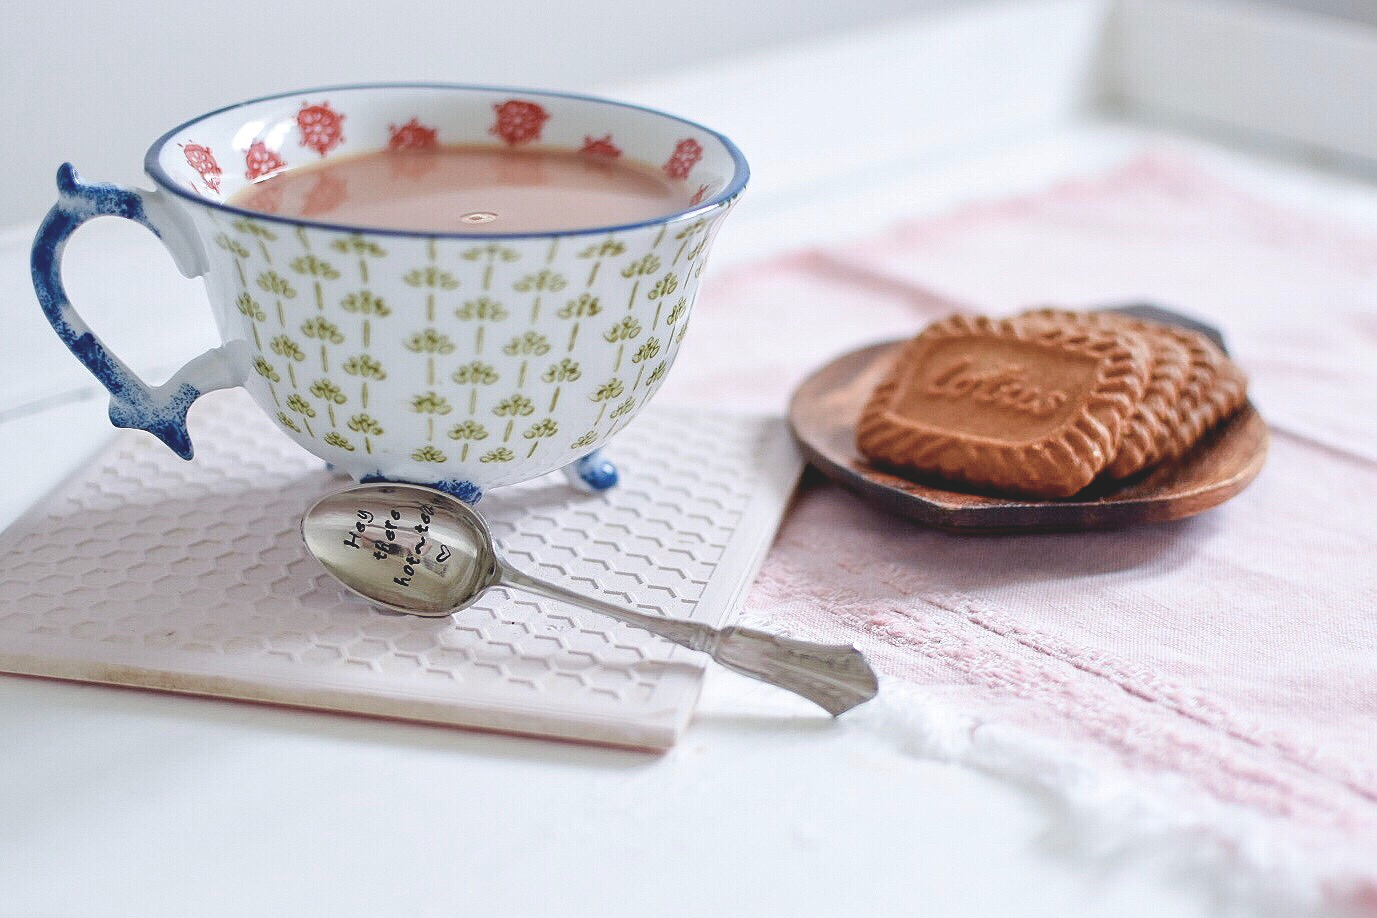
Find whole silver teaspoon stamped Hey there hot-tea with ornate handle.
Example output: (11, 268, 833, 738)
(302, 484, 879, 717)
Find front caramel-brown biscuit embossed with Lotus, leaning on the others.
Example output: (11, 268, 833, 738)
(856, 314, 1153, 497)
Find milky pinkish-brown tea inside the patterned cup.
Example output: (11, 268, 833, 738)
(230, 146, 691, 233)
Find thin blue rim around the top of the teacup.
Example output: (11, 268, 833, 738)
(143, 83, 750, 239)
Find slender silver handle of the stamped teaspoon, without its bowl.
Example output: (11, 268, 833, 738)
(498, 562, 880, 717)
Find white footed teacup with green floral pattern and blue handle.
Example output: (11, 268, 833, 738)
(32, 84, 748, 500)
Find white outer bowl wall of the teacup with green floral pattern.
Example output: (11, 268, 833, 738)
(207, 205, 720, 487)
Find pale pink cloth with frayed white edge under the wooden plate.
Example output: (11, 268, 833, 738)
(655, 154, 1377, 914)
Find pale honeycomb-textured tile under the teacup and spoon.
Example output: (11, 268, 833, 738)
(0, 392, 800, 747)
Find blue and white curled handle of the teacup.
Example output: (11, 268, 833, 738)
(29, 162, 244, 460)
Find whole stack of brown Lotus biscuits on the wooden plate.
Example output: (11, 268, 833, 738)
(856, 310, 1248, 497)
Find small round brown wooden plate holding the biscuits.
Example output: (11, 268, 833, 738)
(789, 341, 1267, 533)
